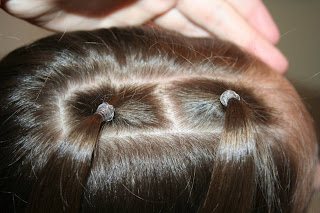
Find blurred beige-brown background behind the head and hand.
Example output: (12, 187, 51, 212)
(0, 0, 320, 213)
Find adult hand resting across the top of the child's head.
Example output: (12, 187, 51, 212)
(2, 0, 288, 73)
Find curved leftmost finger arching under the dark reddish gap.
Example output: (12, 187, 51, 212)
(3, 0, 176, 32)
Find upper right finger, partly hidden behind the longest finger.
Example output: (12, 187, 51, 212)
(227, 0, 280, 44)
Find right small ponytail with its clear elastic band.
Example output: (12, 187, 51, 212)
(200, 90, 272, 213)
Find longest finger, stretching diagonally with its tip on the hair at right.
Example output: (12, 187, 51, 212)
(177, 0, 288, 73)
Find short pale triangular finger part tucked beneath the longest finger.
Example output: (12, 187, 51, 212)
(153, 8, 210, 37)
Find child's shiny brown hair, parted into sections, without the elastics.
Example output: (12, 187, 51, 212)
(0, 28, 317, 212)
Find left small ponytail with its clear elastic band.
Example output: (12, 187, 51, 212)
(28, 103, 114, 212)
